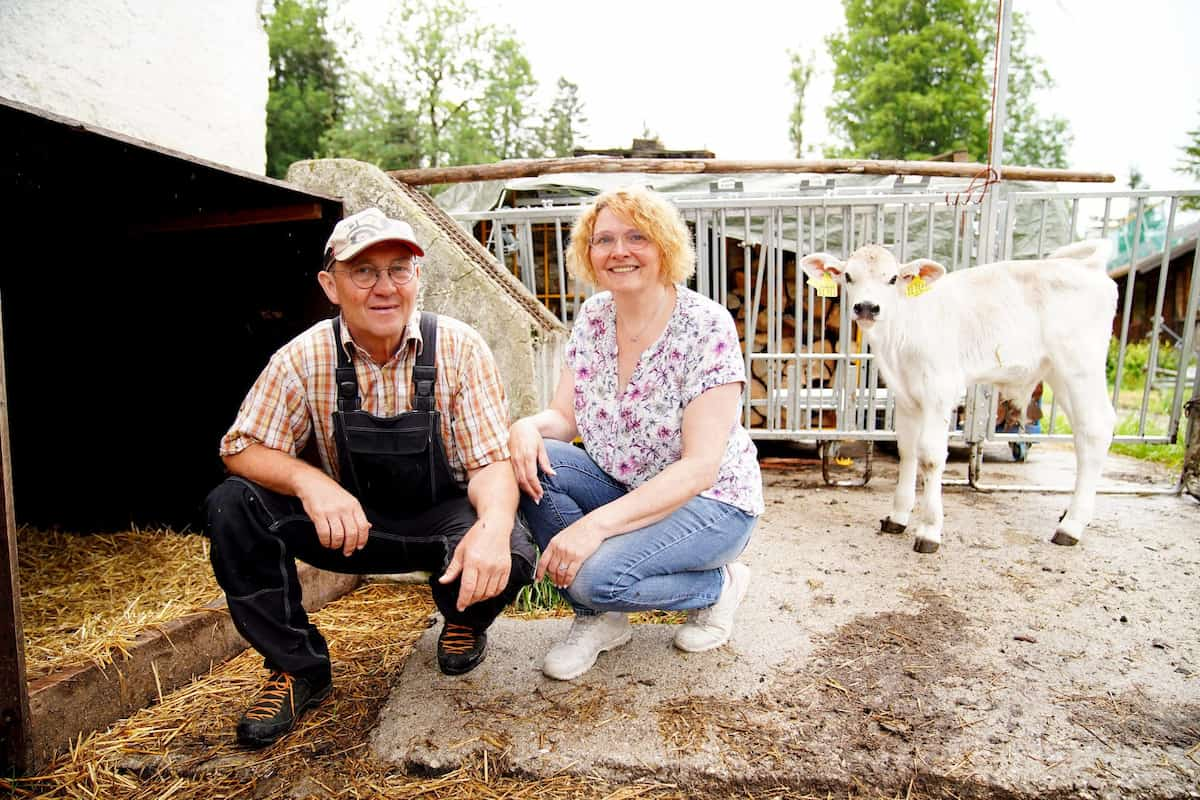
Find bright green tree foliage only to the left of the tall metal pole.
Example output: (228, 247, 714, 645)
(826, 0, 990, 158)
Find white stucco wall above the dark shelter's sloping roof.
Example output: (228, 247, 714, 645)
(0, 0, 269, 174)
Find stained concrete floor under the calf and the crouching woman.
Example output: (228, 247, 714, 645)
(372, 444, 1200, 798)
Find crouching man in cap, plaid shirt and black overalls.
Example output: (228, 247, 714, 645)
(208, 209, 535, 747)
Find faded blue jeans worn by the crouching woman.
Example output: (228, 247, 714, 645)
(521, 439, 757, 615)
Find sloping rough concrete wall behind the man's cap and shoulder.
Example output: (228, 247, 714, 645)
(288, 158, 566, 419)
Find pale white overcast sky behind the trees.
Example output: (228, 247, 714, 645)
(347, 0, 1200, 188)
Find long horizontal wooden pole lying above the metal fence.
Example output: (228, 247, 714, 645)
(388, 156, 1116, 186)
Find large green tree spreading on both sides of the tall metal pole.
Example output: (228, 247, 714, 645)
(820, 0, 1072, 167)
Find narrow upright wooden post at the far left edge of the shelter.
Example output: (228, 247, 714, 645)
(0, 293, 32, 775)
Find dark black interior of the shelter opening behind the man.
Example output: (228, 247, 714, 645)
(0, 101, 342, 533)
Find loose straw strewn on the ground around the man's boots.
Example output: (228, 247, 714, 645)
(0, 584, 705, 800)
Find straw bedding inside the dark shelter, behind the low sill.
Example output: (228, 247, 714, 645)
(17, 527, 221, 680)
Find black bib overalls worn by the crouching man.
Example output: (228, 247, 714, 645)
(206, 313, 536, 685)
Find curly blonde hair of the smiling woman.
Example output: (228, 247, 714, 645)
(566, 186, 696, 285)
